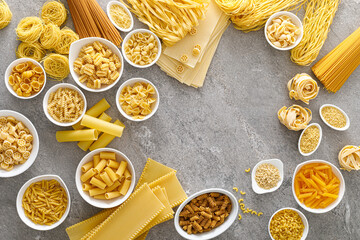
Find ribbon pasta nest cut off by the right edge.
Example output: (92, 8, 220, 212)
(338, 145, 360, 171)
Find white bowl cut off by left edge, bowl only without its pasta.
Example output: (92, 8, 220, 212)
(0, 110, 40, 178)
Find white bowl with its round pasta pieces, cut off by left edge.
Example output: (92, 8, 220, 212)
(0, 110, 39, 178)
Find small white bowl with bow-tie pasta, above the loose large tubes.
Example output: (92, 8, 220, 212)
(116, 78, 160, 122)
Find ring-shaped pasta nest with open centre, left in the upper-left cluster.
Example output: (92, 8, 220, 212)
(16, 17, 44, 43)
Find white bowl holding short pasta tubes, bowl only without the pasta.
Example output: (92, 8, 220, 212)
(75, 148, 136, 208)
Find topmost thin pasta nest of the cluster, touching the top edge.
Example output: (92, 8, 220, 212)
(41, 1, 67, 27)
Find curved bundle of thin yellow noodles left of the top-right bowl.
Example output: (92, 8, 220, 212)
(231, 0, 306, 32)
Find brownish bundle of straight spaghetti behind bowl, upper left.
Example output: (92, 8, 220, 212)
(68, 0, 122, 46)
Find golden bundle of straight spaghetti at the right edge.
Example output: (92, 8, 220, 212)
(311, 28, 360, 92)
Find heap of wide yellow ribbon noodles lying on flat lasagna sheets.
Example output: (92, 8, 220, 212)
(124, 0, 209, 46)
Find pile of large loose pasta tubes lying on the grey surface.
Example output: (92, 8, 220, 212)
(56, 98, 125, 151)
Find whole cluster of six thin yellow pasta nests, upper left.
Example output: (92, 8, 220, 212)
(16, 1, 79, 80)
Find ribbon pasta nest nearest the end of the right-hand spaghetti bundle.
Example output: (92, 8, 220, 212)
(287, 73, 319, 104)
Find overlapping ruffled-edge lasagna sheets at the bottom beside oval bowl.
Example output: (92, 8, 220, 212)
(66, 158, 187, 240)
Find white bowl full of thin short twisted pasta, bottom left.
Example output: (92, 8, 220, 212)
(16, 174, 71, 231)
